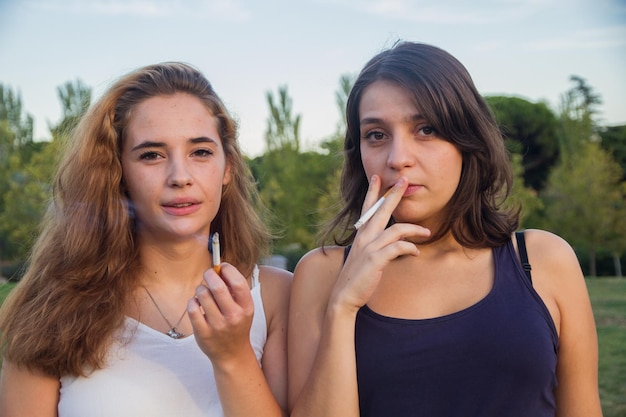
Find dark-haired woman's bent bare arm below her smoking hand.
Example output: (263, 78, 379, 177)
(288, 248, 359, 417)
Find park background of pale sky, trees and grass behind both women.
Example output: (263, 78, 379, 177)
(0, 0, 626, 417)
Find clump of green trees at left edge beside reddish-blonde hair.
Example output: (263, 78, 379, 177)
(0, 81, 91, 260)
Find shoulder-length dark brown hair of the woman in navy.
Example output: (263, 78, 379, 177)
(320, 42, 519, 247)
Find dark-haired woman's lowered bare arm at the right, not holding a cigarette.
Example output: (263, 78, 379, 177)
(525, 230, 602, 417)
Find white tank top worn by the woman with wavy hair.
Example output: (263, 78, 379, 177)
(58, 267, 267, 417)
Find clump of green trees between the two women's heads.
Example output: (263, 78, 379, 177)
(250, 76, 352, 258)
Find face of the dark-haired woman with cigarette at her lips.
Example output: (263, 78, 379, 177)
(359, 80, 463, 227)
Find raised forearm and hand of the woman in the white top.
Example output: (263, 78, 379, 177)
(188, 263, 285, 417)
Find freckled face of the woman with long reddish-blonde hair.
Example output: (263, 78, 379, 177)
(122, 93, 230, 242)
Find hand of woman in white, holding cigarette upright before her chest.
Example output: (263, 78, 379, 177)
(187, 263, 254, 365)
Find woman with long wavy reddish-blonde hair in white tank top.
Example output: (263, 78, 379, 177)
(0, 63, 290, 417)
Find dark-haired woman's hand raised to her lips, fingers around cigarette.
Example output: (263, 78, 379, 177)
(330, 176, 430, 312)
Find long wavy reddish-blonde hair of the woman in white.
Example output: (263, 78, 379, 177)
(0, 62, 271, 377)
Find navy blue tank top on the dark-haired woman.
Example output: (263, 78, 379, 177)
(355, 237, 558, 417)
